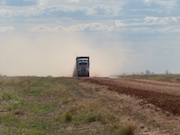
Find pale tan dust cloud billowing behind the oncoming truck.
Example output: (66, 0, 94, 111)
(0, 33, 131, 77)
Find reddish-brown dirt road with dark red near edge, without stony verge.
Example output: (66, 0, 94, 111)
(83, 78, 180, 115)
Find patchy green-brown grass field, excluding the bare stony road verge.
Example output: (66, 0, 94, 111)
(0, 77, 137, 135)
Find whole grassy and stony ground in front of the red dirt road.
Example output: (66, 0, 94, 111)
(0, 77, 180, 135)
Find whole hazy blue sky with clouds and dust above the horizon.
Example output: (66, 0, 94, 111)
(0, 0, 180, 76)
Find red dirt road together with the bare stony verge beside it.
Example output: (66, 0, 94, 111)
(82, 78, 180, 135)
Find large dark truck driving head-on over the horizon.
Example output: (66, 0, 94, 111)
(76, 56, 90, 77)
